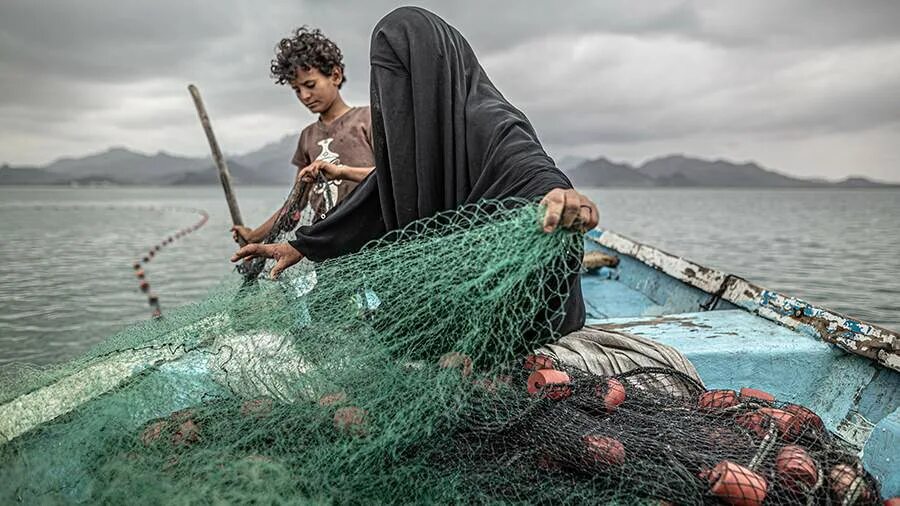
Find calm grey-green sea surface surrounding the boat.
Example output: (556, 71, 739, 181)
(0, 187, 900, 365)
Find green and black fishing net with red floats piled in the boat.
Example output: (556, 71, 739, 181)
(0, 201, 878, 505)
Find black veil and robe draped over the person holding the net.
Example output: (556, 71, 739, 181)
(291, 7, 584, 333)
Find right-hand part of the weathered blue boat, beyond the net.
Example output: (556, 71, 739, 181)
(582, 230, 900, 497)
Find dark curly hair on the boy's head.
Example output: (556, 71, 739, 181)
(271, 25, 347, 88)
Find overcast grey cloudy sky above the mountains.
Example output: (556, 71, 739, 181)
(0, 0, 900, 181)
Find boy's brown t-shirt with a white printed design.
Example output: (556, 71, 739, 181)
(291, 107, 375, 222)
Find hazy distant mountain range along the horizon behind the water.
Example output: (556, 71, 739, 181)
(0, 139, 900, 188)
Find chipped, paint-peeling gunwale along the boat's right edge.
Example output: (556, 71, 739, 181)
(585, 228, 900, 372)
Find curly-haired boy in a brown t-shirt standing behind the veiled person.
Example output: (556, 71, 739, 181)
(231, 26, 375, 243)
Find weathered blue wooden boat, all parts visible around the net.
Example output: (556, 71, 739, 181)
(0, 230, 900, 497)
